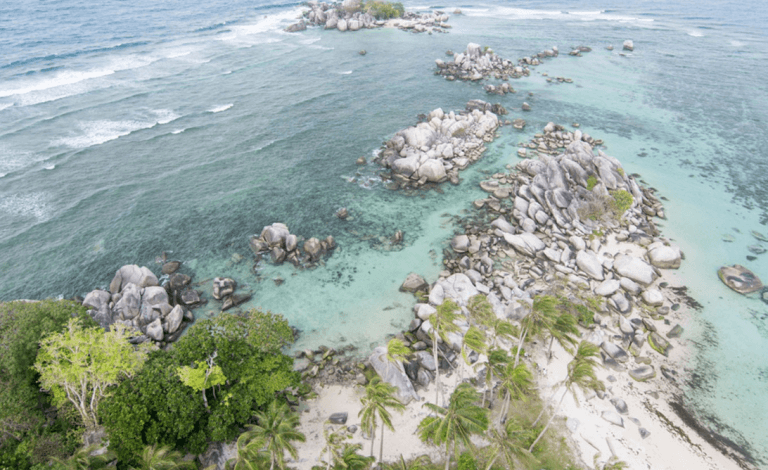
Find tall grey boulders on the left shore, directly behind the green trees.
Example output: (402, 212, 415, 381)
(83, 261, 195, 345)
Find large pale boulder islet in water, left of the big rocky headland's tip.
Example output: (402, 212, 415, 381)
(375, 100, 506, 189)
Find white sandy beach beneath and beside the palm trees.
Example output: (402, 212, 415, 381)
(293, 260, 745, 470)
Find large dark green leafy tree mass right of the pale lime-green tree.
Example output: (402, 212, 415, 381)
(99, 310, 299, 464)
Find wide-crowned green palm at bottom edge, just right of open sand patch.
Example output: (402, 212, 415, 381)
(417, 383, 488, 470)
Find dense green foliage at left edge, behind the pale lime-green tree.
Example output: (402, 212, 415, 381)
(0, 300, 95, 469)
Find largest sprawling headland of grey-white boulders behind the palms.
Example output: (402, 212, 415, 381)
(369, 124, 683, 408)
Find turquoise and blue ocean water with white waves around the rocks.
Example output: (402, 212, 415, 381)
(0, 0, 768, 468)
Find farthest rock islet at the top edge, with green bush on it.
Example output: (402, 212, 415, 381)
(286, 0, 451, 33)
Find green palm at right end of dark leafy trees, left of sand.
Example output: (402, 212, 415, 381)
(248, 400, 305, 470)
